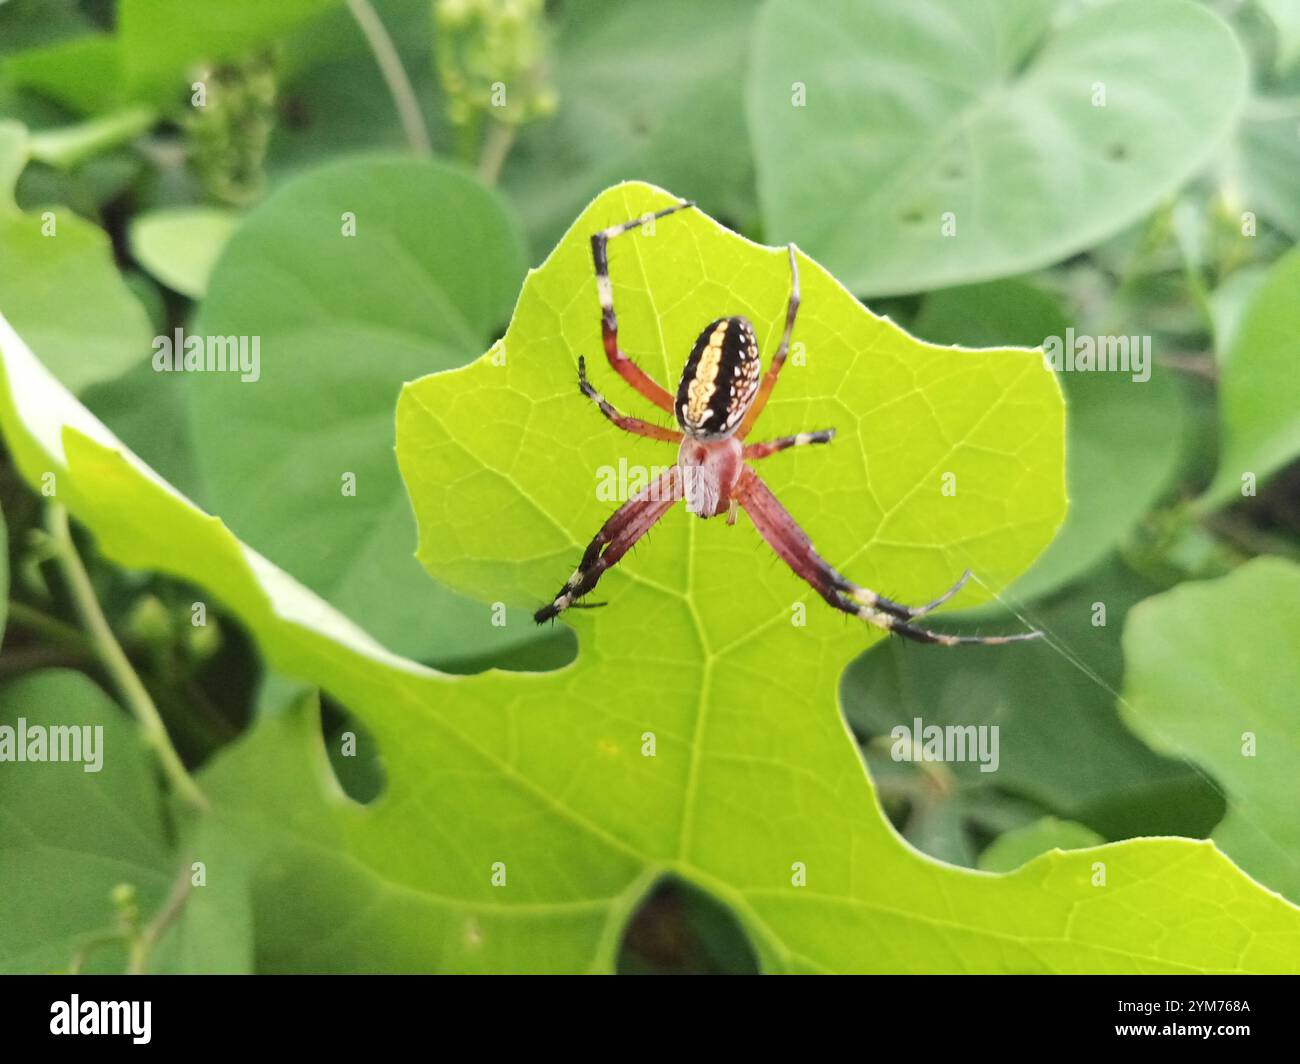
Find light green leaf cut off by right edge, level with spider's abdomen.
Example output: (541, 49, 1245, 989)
(1201, 247, 1300, 507)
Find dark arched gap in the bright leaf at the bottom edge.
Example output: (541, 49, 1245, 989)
(618, 877, 758, 976)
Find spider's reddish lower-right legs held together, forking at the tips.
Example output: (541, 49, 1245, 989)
(736, 470, 1040, 646)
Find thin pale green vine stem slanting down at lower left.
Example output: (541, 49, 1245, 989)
(46, 502, 208, 812)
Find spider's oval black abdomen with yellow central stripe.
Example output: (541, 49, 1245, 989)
(673, 317, 761, 440)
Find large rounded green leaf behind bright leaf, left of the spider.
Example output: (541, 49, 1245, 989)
(186, 160, 537, 663)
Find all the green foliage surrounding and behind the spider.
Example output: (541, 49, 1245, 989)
(0, 0, 1300, 972)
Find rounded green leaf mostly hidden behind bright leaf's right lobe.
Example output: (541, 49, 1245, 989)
(915, 281, 1182, 600)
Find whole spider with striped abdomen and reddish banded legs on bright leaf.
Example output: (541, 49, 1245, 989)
(533, 200, 1040, 646)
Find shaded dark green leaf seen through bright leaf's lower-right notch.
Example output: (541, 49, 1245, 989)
(840, 561, 1223, 847)
